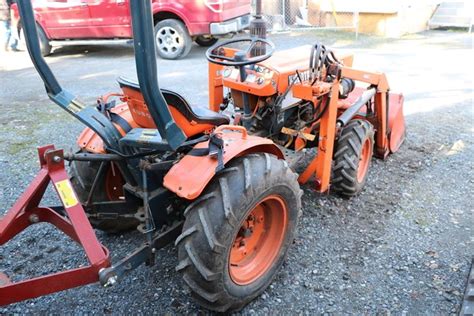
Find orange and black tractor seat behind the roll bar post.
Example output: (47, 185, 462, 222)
(117, 77, 230, 137)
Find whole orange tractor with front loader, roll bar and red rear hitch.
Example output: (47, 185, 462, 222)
(0, 0, 405, 312)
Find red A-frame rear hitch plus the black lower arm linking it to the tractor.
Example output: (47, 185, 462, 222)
(0, 145, 183, 306)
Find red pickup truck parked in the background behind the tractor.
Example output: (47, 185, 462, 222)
(12, 0, 251, 59)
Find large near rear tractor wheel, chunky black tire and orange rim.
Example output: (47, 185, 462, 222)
(176, 154, 302, 312)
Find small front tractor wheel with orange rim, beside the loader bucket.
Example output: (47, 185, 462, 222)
(331, 120, 374, 198)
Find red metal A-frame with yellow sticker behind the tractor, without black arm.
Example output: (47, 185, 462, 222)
(0, 145, 110, 305)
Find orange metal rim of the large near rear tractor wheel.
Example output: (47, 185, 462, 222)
(229, 195, 288, 285)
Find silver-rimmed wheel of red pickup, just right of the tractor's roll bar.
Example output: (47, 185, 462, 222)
(155, 19, 193, 59)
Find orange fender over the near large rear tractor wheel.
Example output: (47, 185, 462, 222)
(163, 125, 284, 200)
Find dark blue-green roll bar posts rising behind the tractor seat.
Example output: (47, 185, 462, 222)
(17, 0, 186, 151)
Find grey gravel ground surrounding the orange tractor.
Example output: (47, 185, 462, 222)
(0, 31, 474, 315)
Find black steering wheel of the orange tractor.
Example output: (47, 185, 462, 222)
(206, 38, 275, 67)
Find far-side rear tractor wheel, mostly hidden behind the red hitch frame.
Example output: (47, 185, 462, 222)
(70, 161, 140, 234)
